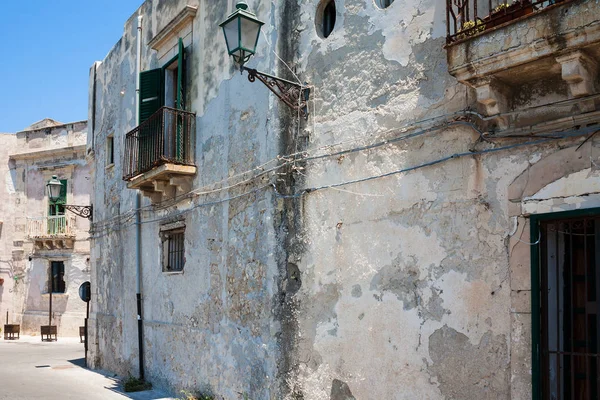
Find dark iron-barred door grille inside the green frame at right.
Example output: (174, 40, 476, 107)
(540, 217, 600, 400)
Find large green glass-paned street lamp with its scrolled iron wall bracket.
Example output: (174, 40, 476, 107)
(219, 2, 310, 118)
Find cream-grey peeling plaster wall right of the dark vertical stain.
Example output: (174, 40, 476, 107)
(290, 0, 599, 399)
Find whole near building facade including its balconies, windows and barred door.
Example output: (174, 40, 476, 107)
(88, 0, 600, 400)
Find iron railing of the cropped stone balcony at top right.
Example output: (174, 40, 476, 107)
(446, 0, 571, 44)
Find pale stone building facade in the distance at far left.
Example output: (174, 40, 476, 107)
(0, 119, 91, 337)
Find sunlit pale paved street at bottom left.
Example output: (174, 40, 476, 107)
(0, 337, 172, 400)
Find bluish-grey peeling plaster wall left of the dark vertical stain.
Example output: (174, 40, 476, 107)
(88, 1, 283, 399)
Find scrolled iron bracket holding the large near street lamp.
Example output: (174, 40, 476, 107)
(240, 66, 310, 119)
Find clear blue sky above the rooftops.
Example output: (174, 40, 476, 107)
(0, 0, 143, 132)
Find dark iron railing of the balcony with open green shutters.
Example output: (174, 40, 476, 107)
(123, 107, 196, 181)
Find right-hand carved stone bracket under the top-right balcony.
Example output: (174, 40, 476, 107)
(556, 50, 598, 112)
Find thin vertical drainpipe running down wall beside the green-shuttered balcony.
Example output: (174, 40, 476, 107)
(135, 15, 144, 380)
